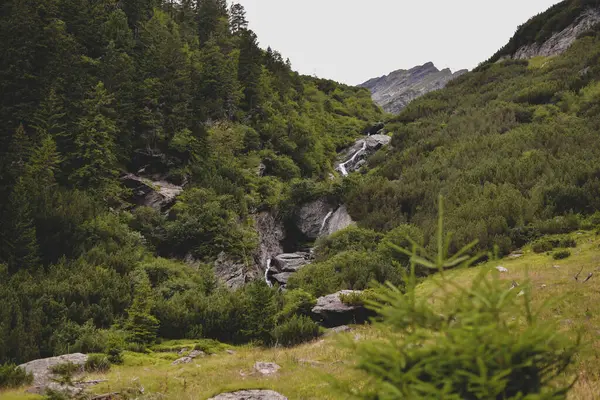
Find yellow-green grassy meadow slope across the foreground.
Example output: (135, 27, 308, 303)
(0, 233, 600, 400)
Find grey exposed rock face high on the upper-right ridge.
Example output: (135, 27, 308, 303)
(513, 9, 600, 59)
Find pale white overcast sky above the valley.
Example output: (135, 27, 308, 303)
(236, 0, 559, 84)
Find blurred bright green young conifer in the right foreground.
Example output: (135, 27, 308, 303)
(347, 201, 579, 400)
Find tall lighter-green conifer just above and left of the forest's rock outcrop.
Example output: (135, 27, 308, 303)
(69, 82, 117, 188)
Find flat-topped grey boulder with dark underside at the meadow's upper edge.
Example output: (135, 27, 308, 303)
(312, 290, 372, 328)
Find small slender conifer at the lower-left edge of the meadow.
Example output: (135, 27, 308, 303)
(125, 271, 160, 344)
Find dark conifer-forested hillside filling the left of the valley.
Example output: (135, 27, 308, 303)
(0, 0, 381, 362)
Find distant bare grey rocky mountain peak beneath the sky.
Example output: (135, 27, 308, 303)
(359, 62, 468, 114)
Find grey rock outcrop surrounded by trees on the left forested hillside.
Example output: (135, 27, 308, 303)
(121, 174, 183, 211)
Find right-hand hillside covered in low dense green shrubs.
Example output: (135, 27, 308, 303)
(346, 1, 600, 254)
